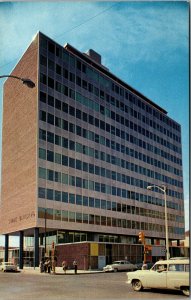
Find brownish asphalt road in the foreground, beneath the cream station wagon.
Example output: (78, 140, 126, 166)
(0, 272, 186, 300)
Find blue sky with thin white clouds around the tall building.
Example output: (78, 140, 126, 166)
(0, 1, 189, 246)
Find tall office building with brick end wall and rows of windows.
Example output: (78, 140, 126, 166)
(0, 33, 184, 265)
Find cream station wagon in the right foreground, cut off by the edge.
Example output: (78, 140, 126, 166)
(127, 259, 190, 296)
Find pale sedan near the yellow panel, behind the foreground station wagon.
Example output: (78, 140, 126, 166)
(103, 260, 137, 272)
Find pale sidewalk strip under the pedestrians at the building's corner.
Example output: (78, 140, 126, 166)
(20, 267, 103, 276)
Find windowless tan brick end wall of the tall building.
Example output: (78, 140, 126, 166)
(0, 36, 38, 233)
